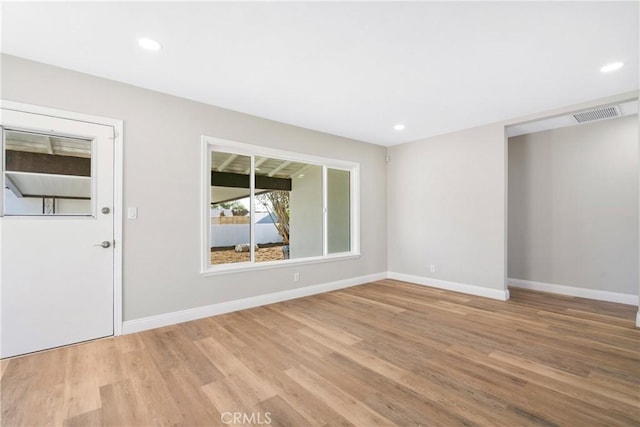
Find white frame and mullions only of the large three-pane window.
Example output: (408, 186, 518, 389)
(200, 135, 360, 276)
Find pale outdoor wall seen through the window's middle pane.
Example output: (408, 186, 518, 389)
(289, 166, 323, 259)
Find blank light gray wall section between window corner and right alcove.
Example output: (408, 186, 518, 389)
(387, 125, 506, 289)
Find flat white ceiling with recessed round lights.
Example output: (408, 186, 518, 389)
(1, 1, 640, 145)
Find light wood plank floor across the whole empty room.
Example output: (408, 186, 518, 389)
(1, 280, 640, 427)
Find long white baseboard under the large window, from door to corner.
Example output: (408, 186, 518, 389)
(122, 272, 387, 334)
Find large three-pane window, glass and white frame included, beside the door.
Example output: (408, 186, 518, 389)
(202, 136, 359, 273)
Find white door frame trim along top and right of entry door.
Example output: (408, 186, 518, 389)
(0, 100, 124, 336)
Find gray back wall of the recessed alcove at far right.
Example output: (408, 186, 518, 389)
(508, 116, 638, 295)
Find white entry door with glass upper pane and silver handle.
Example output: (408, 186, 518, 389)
(0, 109, 114, 358)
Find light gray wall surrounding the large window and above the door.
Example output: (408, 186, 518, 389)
(0, 55, 387, 320)
